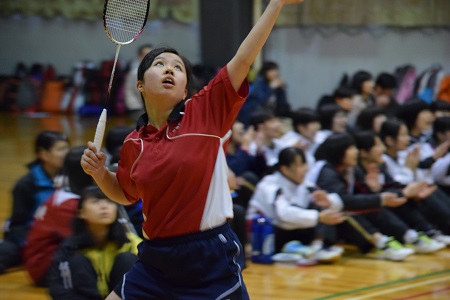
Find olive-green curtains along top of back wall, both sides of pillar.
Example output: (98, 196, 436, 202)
(0, 0, 450, 28)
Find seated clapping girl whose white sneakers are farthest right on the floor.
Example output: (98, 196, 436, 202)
(354, 131, 450, 253)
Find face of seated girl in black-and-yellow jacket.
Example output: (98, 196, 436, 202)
(80, 197, 117, 225)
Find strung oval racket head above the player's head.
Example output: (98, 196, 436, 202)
(103, 0, 150, 45)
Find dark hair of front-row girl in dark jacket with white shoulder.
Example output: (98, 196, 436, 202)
(314, 133, 355, 166)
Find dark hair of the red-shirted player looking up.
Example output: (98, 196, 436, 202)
(137, 47, 194, 98)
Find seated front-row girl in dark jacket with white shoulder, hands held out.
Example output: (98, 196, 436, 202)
(308, 134, 420, 260)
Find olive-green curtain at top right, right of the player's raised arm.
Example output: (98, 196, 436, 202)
(277, 0, 450, 28)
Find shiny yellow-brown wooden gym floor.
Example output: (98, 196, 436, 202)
(0, 113, 450, 300)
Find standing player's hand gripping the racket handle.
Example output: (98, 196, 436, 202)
(80, 142, 107, 181)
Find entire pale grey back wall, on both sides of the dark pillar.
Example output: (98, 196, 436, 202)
(0, 17, 450, 108)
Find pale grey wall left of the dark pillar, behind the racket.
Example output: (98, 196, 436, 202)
(0, 17, 200, 75)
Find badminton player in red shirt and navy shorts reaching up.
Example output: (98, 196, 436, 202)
(81, 0, 303, 299)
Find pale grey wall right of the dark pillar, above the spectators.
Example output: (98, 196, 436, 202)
(264, 28, 450, 107)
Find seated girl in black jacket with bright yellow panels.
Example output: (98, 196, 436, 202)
(49, 186, 141, 300)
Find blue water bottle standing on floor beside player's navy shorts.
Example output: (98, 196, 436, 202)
(252, 216, 275, 264)
